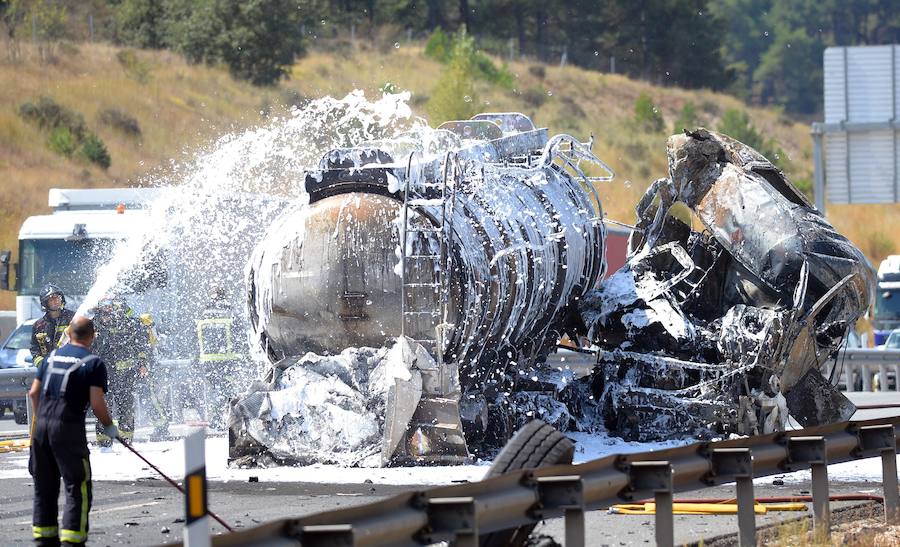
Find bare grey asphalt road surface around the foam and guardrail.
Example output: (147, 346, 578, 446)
(0, 393, 900, 545)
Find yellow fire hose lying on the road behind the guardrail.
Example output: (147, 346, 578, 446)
(609, 494, 884, 515)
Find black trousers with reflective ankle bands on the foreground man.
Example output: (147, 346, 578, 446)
(29, 397, 92, 545)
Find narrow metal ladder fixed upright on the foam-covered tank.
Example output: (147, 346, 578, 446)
(400, 153, 460, 370)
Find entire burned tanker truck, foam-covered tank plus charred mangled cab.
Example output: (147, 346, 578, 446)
(229, 114, 872, 465)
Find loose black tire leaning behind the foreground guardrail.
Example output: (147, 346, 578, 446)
(479, 420, 575, 547)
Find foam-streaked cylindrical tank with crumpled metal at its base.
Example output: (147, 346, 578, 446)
(230, 114, 612, 465)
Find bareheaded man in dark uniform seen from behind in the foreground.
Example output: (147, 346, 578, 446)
(29, 316, 118, 546)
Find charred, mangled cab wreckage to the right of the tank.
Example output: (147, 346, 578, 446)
(581, 129, 873, 441)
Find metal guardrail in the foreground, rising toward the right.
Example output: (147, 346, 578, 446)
(195, 417, 900, 547)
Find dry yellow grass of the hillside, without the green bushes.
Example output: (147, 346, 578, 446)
(0, 41, 900, 309)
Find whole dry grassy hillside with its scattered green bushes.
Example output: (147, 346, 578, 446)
(0, 31, 900, 308)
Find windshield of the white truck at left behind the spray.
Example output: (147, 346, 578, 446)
(18, 239, 115, 296)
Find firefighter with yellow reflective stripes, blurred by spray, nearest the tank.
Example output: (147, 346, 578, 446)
(195, 287, 243, 427)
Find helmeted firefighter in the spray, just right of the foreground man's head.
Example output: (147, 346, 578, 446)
(92, 297, 152, 447)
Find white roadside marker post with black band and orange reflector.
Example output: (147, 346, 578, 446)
(184, 427, 211, 547)
